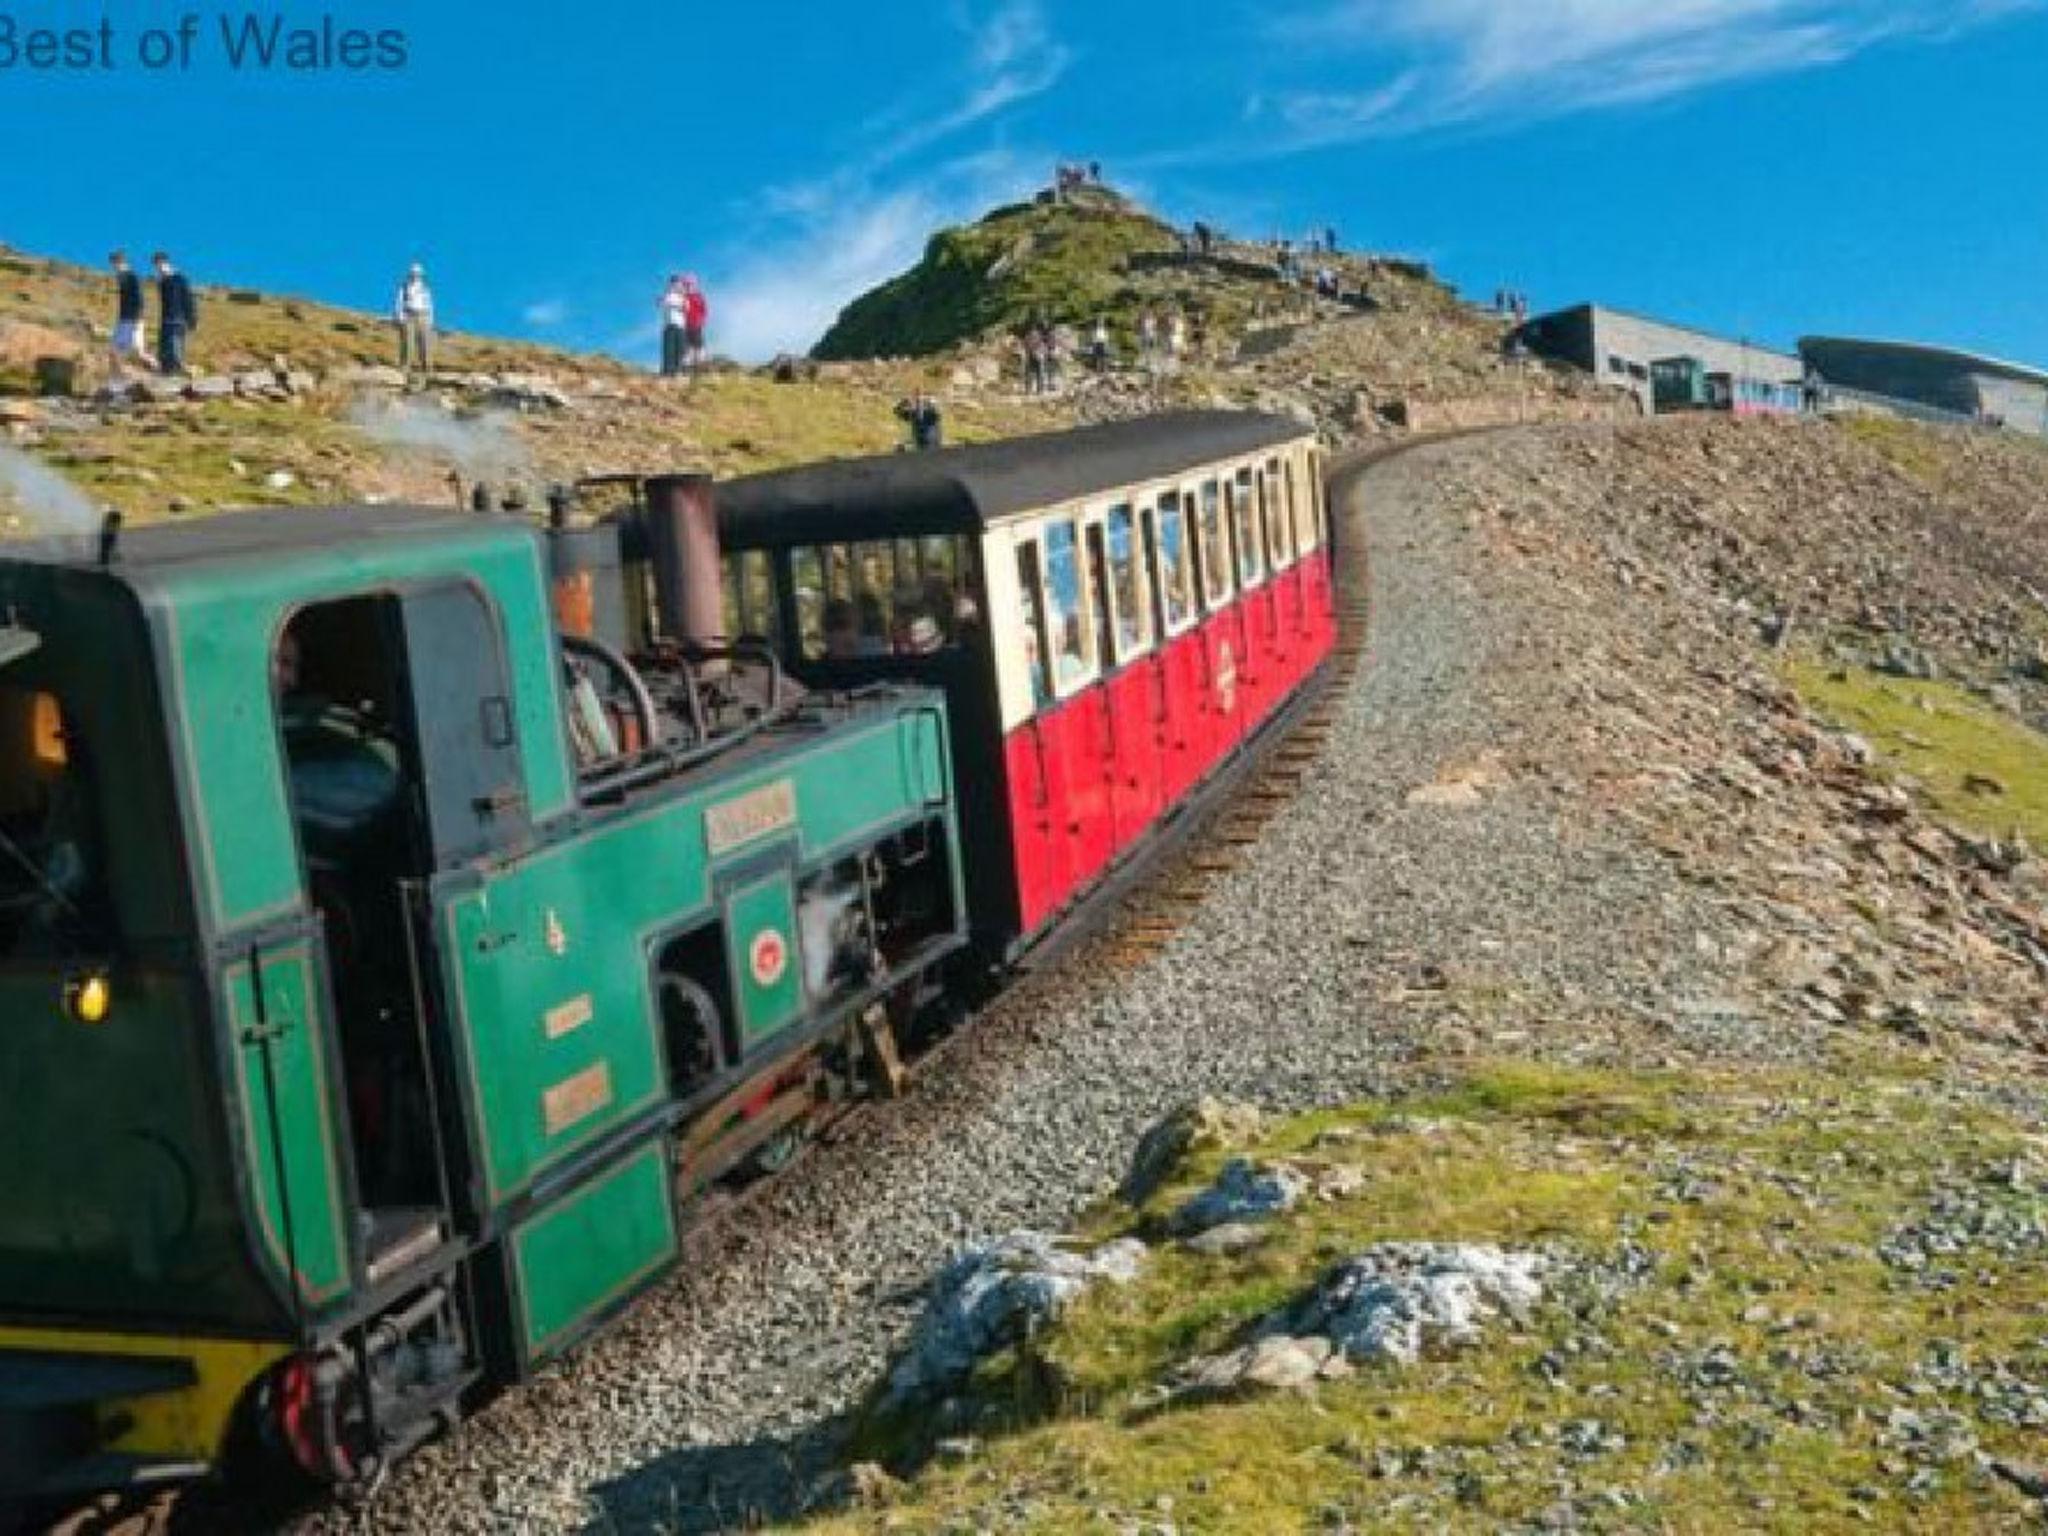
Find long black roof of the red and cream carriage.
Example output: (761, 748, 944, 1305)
(719, 410, 1311, 549)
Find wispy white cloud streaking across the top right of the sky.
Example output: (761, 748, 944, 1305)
(1220, 0, 2048, 158)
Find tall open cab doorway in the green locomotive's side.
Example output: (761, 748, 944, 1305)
(272, 586, 524, 1284)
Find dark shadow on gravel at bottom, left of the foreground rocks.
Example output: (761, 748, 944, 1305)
(588, 1421, 846, 1536)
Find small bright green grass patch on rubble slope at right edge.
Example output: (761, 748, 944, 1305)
(1790, 662, 2048, 846)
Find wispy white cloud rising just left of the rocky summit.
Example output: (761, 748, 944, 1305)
(713, 0, 1073, 360)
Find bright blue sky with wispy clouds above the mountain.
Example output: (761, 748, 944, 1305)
(0, 0, 2048, 365)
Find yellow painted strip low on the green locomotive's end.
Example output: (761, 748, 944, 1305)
(0, 1327, 291, 1464)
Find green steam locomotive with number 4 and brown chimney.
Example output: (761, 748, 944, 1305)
(0, 477, 965, 1513)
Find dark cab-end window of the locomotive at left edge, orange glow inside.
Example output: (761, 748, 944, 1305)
(0, 684, 106, 958)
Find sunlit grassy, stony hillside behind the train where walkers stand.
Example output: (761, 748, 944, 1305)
(0, 248, 1071, 537)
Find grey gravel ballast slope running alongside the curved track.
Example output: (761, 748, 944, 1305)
(327, 434, 1714, 1532)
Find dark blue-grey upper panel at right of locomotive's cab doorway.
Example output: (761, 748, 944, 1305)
(401, 586, 530, 870)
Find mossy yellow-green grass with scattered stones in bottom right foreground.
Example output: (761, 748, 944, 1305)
(811, 1042, 2048, 1534)
